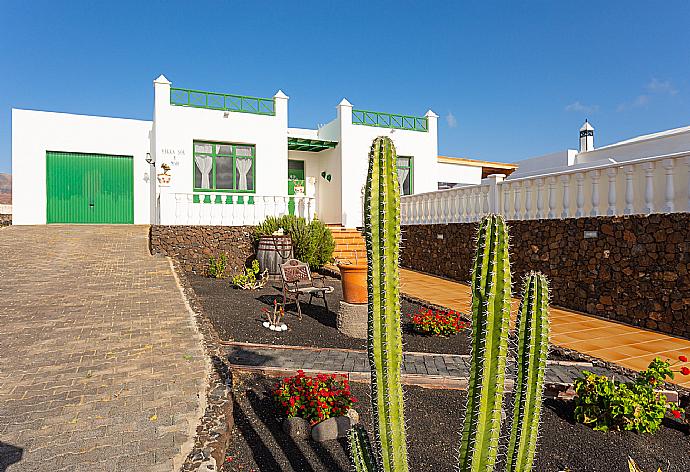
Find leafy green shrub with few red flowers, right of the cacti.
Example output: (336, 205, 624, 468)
(575, 358, 673, 433)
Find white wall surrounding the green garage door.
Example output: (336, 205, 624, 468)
(12, 109, 155, 225)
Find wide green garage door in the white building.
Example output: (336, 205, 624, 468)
(46, 151, 134, 223)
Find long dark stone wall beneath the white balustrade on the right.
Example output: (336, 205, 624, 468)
(401, 213, 690, 338)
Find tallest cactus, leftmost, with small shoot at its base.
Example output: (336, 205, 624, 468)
(350, 136, 408, 472)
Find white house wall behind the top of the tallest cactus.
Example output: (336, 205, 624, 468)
(338, 100, 438, 228)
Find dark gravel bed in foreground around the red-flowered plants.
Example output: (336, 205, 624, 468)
(222, 375, 690, 472)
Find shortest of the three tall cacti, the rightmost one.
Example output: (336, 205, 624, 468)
(506, 272, 549, 472)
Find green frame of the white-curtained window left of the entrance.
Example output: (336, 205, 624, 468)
(192, 140, 256, 194)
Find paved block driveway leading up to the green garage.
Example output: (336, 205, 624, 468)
(0, 226, 207, 472)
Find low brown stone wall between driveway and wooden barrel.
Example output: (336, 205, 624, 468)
(149, 225, 254, 275)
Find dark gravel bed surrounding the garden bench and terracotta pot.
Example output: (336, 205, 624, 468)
(188, 274, 470, 354)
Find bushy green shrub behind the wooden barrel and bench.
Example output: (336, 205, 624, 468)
(254, 215, 335, 269)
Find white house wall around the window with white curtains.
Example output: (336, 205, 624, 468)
(154, 77, 288, 221)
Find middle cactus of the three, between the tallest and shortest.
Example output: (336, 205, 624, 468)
(459, 215, 511, 472)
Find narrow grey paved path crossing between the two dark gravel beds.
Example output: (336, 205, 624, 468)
(225, 343, 620, 390)
